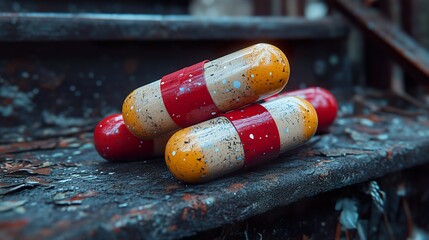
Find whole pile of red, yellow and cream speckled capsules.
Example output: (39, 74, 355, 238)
(94, 43, 337, 183)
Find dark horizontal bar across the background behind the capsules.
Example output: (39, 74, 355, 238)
(0, 13, 348, 41)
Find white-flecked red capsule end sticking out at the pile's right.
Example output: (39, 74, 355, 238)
(265, 87, 338, 131)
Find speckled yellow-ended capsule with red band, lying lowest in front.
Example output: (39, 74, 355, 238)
(165, 97, 318, 183)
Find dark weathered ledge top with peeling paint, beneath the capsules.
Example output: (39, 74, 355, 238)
(0, 112, 429, 239)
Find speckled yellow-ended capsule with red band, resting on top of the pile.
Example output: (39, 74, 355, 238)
(122, 43, 290, 139)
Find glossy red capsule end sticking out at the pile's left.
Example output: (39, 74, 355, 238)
(94, 113, 169, 162)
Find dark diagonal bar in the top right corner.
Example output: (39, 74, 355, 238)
(332, 0, 429, 82)
